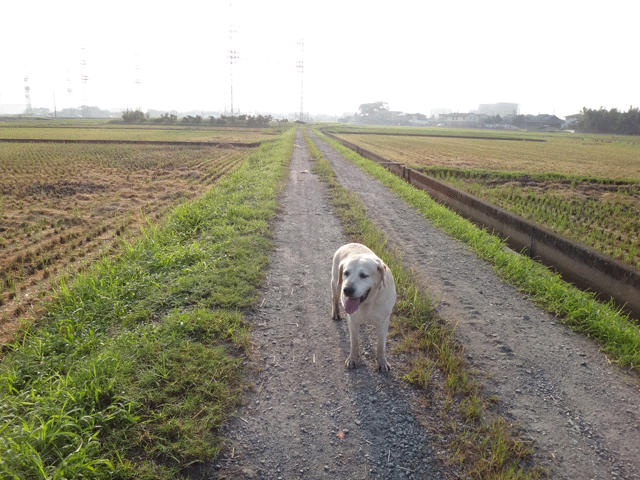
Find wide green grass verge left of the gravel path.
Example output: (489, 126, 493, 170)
(0, 129, 294, 479)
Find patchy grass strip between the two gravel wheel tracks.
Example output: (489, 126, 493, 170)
(305, 129, 543, 480)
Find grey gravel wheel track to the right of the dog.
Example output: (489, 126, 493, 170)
(306, 131, 640, 479)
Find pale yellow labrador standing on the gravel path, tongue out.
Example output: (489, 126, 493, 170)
(331, 243, 396, 372)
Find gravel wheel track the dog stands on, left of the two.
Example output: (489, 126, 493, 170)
(207, 131, 445, 480)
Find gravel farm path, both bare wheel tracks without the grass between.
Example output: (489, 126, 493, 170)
(213, 134, 640, 479)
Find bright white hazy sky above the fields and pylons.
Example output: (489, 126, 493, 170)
(0, 0, 640, 117)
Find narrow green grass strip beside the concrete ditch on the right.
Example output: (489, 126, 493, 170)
(320, 128, 640, 372)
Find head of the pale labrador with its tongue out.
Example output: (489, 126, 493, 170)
(338, 253, 387, 314)
